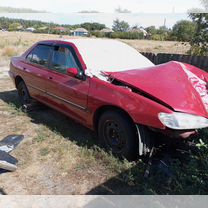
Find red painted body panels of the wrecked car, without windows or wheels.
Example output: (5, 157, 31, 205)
(10, 41, 208, 135)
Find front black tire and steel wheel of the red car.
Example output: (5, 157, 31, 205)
(98, 111, 139, 161)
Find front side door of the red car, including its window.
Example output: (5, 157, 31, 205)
(46, 45, 89, 123)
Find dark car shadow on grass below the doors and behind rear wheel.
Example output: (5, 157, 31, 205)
(0, 90, 98, 148)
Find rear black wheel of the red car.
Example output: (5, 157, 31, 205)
(17, 81, 31, 106)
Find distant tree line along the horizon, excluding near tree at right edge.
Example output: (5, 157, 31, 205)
(0, 17, 196, 42)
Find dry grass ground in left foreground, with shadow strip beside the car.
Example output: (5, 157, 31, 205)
(0, 79, 133, 194)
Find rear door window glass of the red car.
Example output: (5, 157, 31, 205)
(27, 45, 51, 66)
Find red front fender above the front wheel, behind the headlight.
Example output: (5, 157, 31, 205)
(88, 78, 173, 129)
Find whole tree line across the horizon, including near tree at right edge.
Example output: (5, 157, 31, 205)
(0, 13, 208, 56)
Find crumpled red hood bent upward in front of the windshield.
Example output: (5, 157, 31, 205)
(108, 61, 208, 117)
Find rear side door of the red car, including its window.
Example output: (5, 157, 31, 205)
(21, 44, 52, 100)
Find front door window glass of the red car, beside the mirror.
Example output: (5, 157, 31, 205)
(51, 46, 78, 74)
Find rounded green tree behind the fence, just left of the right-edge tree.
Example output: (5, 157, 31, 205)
(171, 20, 196, 42)
